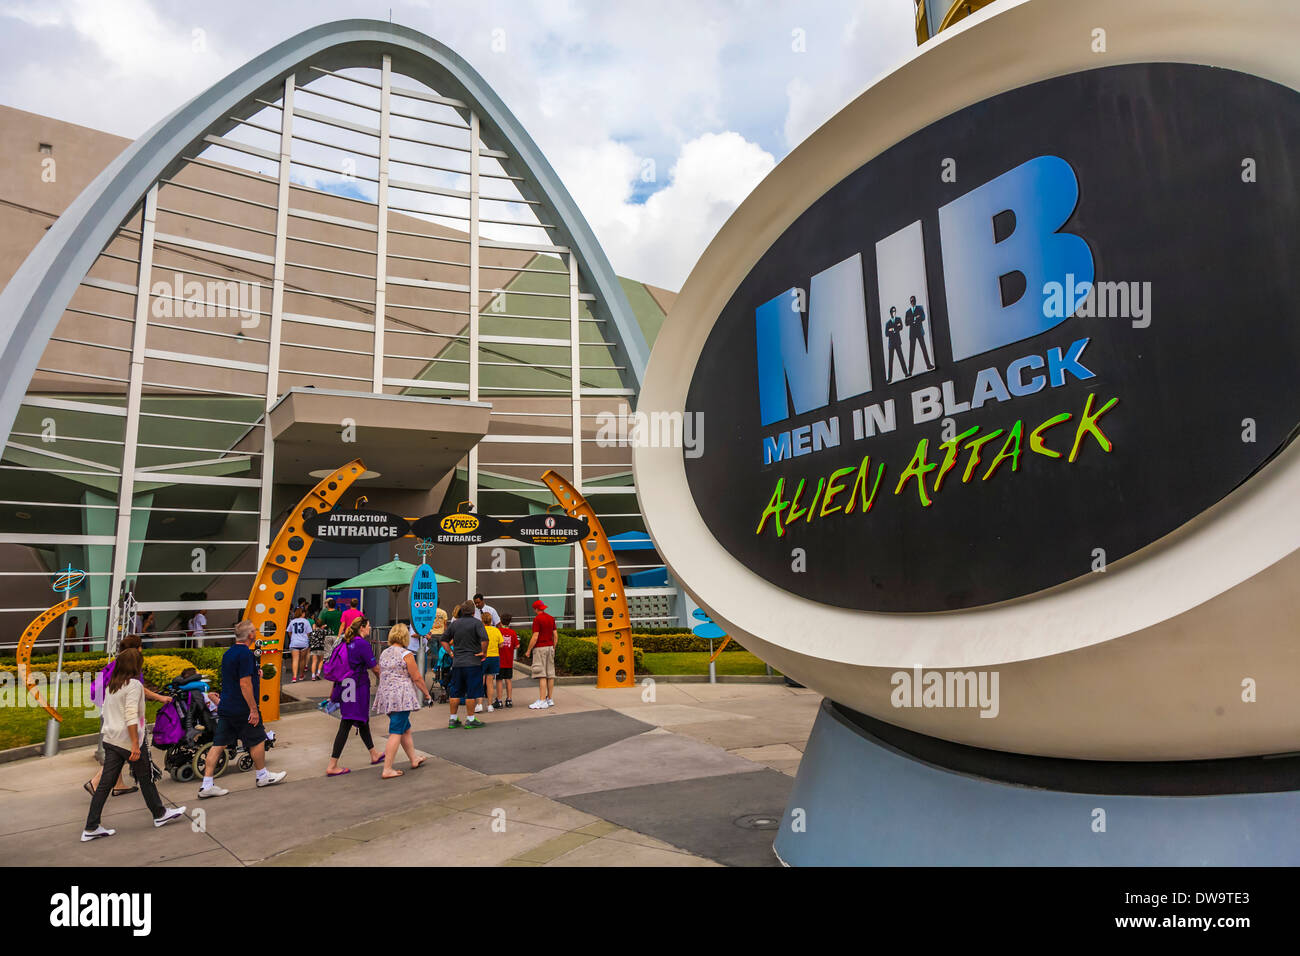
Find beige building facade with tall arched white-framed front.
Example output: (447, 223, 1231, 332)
(0, 21, 681, 643)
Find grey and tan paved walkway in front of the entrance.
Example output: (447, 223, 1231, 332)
(0, 682, 820, 866)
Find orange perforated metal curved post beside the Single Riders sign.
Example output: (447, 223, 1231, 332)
(542, 471, 636, 687)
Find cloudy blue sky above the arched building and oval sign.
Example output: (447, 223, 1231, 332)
(0, 0, 915, 289)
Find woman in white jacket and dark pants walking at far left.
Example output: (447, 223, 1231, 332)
(82, 648, 185, 843)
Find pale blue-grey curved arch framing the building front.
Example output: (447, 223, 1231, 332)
(0, 20, 649, 436)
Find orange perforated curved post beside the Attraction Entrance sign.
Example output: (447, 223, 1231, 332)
(244, 458, 365, 721)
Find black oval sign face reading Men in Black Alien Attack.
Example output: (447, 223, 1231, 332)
(685, 64, 1300, 611)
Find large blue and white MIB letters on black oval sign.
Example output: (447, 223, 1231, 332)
(755, 156, 1093, 429)
